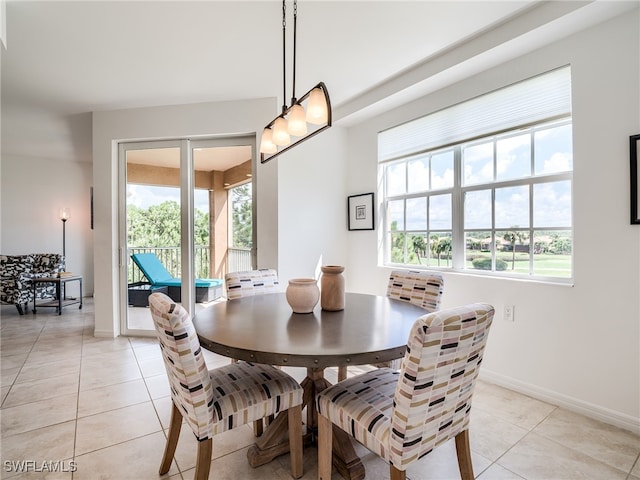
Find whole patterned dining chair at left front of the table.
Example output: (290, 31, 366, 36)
(149, 293, 303, 480)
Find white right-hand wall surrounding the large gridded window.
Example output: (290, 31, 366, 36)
(347, 9, 640, 431)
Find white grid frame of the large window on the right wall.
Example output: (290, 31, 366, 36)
(378, 114, 575, 284)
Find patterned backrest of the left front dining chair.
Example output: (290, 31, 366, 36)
(149, 293, 214, 440)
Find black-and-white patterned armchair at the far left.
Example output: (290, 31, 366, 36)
(0, 253, 64, 315)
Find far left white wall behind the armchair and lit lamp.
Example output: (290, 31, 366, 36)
(0, 156, 93, 296)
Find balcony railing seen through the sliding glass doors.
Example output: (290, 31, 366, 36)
(127, 246, 252, 284)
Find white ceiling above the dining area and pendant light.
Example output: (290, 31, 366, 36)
(1, 0, 637, 169)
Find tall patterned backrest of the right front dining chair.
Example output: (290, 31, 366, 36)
(390, 303, 494, 470)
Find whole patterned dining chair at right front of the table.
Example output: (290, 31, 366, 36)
(316, 303, 494, 480)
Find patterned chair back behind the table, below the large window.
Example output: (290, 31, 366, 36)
(387, 270, 444, 312)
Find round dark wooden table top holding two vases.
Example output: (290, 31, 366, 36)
(193, 293, 427, 368)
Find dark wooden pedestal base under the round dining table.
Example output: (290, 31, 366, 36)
(247, 368, 365, 480)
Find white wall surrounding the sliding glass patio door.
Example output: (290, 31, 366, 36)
(93, 99, 278, 337)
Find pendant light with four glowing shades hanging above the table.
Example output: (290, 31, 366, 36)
(260, 0, 331, 163)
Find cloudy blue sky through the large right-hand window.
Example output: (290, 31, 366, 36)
(386, 123, 573, 230)
